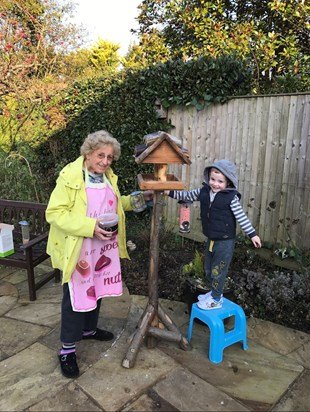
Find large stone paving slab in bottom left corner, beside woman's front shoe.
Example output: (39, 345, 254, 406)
(0, 343, 68, 411)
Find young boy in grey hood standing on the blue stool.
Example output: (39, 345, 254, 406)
(165, 159, 261, 310)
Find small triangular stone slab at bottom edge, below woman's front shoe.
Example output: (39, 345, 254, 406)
(26, 382, 102, 412)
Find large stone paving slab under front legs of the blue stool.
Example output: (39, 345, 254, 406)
(159, 325, 303, 410)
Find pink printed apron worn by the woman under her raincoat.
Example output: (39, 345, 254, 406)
(69, 172, 123, 312)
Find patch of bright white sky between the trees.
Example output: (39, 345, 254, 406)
(73, 0, 141, 55)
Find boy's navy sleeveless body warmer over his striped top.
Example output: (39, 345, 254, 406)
(199, 184, 241, 240)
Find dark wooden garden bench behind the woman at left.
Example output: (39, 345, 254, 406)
(0, 199, 60, 301)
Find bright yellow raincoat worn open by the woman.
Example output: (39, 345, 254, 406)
(46, 156, 132, 283)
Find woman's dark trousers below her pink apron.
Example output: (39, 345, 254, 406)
(60, 283, 101, 343)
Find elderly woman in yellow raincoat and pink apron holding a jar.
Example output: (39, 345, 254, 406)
(46, 130, 149, 378)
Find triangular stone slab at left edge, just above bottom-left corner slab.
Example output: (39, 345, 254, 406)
(0, 317, 51, 360)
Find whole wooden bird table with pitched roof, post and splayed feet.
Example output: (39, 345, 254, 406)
(122, 132, 191, 368)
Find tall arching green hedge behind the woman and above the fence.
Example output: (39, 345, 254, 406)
(1, 56, 252, 201)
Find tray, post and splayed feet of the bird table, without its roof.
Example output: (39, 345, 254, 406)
(122, 164, 189, 368)
